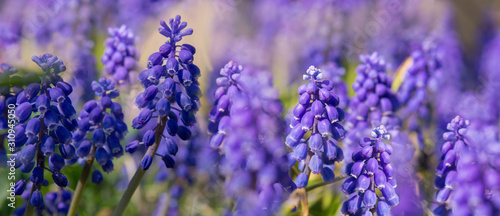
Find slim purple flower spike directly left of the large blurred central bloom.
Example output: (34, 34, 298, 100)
(208, 61, 243, 148)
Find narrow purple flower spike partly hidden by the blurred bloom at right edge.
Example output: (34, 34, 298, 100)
(434, 116, 470, 215)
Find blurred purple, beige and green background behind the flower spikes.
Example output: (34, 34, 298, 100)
(0, 0, 500, 216)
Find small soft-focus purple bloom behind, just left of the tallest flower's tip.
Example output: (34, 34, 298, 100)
(101, 25, 138, 83)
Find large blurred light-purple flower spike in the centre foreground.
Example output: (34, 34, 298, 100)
(219, 70, 293, 215)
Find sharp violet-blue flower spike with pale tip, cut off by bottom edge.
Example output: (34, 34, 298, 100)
(341, 126, 399, 216)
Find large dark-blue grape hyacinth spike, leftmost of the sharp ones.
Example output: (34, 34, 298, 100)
(12, 54, 78, 209)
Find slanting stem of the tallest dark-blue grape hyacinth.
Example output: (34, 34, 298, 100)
(112, 117, 167, 216)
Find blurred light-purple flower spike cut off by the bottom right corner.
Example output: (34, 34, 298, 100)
(441, 125, 500, 216)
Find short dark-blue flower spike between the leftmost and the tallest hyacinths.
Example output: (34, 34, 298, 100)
(73, 78, 128, 179)
